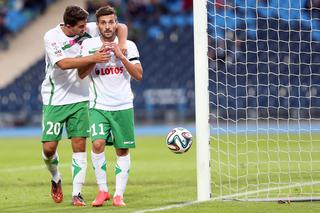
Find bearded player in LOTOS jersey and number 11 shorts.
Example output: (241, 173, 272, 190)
(78, 6, 143, 207)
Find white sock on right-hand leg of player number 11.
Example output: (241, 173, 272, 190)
(114, 154, 130, 196)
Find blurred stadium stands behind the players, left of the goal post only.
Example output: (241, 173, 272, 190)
(0, 0, 195, 127)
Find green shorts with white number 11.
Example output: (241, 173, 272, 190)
(89, 109, 136, 148)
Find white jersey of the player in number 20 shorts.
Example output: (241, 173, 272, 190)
(41, 22, 99, 105)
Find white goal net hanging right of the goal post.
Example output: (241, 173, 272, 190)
(195, 0, 320, 201)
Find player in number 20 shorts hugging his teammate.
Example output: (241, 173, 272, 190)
(41, 6, 127, 206)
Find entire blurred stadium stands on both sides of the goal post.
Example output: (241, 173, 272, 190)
(0, 0, 320, 127)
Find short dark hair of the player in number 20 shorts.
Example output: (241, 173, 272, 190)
(63, 5, 89, 27)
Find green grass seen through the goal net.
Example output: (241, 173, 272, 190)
(211, 134, 320, 199)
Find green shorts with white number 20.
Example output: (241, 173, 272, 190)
(42, 101, 89, 142)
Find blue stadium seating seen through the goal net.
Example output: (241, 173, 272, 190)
(208, 0, 320, 120)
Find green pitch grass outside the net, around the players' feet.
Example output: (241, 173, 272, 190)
(0, 137, 320, 213)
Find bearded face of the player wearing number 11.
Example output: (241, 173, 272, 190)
(97, 14, 117, 40)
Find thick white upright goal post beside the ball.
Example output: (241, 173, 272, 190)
(193, 0, 211, 201)
